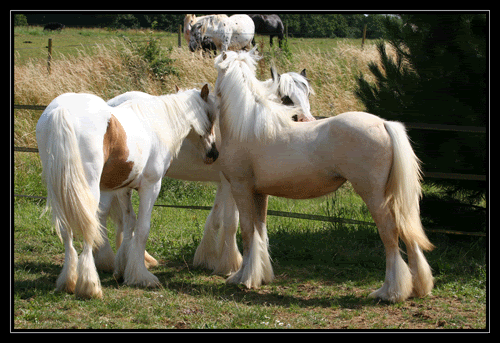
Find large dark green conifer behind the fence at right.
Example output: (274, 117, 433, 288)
(356, 14, 488, 202)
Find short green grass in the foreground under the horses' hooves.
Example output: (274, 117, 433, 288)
(13, 175, 487, 329)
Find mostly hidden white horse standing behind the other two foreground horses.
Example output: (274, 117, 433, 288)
(95, 68, 314, 275)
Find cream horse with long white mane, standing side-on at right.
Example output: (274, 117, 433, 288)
(215, 51, 433, 302)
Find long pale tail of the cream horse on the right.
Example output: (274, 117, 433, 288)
(384, 121, 434, 250)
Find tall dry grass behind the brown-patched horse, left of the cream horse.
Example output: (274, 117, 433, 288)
(14, 41, 217, 105)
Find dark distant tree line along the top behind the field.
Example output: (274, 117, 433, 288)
(14, 13, 398, 38)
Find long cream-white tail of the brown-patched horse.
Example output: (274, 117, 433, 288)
(43, 107, 103, 250)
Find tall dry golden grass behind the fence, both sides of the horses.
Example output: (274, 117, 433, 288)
(14, 41, 384, 146)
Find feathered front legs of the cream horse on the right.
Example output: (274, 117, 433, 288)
(227, 183, 274, 288)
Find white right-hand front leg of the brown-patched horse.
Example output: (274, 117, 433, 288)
(123, 179, 161, 287)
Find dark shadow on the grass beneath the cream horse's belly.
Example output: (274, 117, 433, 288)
(146, 227, 392, 308)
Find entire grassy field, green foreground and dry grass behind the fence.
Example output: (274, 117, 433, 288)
(11, 28, 488, 330)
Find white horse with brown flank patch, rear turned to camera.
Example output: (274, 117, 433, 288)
(36, 85, 218, 298)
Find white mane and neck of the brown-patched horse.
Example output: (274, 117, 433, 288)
(118, 89, 215, 157)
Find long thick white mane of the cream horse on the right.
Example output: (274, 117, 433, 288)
(215, 50, 300, 142)
